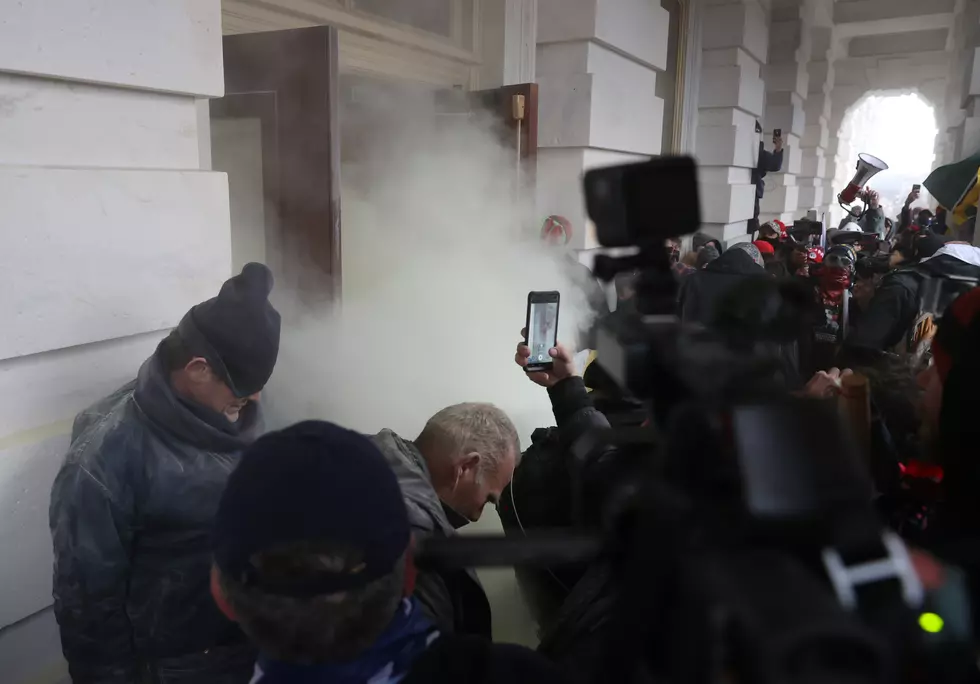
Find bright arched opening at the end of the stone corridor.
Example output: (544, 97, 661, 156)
(831, 92, 939, 227)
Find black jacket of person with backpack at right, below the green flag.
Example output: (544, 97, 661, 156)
(847, 245, 980, 351)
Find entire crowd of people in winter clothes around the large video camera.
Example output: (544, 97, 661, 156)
(50, 178, 980, 684)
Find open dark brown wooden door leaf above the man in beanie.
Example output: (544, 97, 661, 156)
(211, 26, 341, 303)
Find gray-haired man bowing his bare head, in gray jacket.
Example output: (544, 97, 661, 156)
(374, 403, 521, 638)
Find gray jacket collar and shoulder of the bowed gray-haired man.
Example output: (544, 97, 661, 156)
(371, 429, 455, 535)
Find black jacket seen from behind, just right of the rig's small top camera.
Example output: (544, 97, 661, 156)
(680, 249, 769, 326)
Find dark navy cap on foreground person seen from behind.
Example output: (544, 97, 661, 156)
(213, 421, 411, 597)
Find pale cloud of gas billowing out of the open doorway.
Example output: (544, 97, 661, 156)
(269, 83, 589, 447)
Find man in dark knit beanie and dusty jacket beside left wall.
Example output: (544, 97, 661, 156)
(50, 264, 280, 684)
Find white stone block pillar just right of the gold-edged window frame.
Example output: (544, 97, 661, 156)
(696, 0, 769, 242)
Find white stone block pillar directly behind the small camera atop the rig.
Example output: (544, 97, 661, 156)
(537, 0, 669, 250)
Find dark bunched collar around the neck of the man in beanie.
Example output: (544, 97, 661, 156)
(133, 354, 262, 453)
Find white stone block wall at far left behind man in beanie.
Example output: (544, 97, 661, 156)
(0, 0, 231, 682)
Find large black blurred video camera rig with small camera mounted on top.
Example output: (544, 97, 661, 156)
(420, 157, 976, 682)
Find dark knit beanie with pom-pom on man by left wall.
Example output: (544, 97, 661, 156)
(177, 263, 281, 397)
